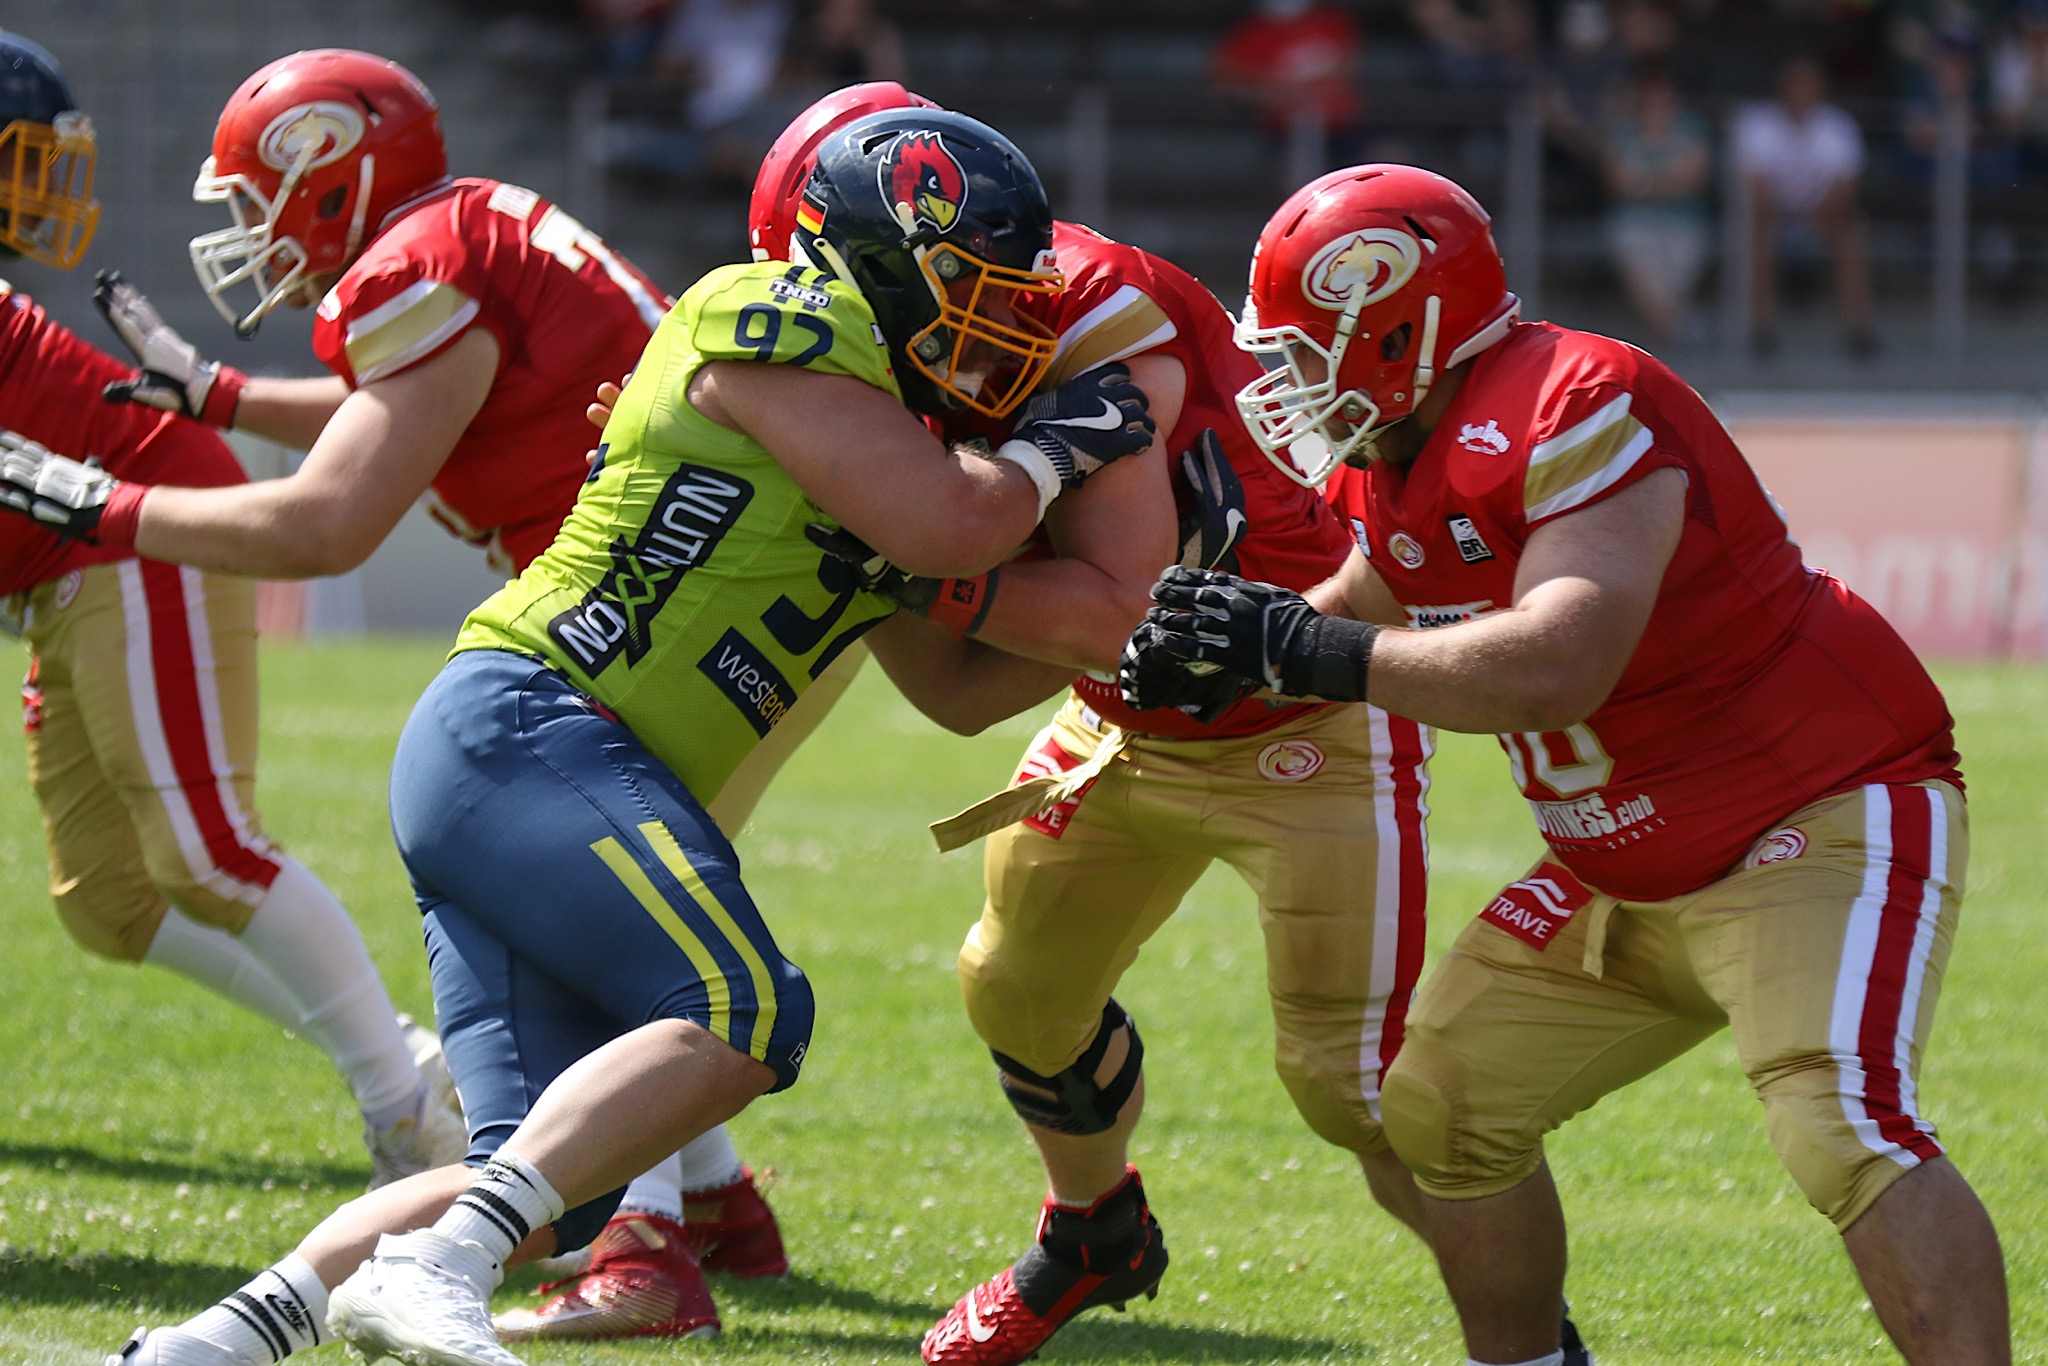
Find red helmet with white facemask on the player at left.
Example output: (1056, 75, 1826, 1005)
(193, 47, 449, 336)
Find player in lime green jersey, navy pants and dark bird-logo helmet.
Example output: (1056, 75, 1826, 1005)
(111, 109, 1153, 1366)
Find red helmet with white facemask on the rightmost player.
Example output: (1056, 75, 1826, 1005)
(1237, 166, 1522, 487)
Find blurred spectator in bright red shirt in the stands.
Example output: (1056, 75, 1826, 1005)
(1214, 0, 1366, 184)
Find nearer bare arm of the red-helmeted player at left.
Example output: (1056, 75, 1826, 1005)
(135, 328, 498, 578)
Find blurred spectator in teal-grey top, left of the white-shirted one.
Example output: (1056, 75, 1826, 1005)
(1602, 66, 1710, 346)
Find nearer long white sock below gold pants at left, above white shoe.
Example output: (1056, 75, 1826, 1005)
(242, 858, 422, 1126)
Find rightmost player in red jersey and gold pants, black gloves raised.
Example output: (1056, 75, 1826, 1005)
(1124, 166, 2009, 1362)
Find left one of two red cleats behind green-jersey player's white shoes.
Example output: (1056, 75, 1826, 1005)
(492, 1214, 719, 1341)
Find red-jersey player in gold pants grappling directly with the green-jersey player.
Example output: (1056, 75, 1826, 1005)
(729, 88, 1430, 1366)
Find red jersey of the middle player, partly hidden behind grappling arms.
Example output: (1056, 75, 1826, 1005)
(946, 223, 1350, 739)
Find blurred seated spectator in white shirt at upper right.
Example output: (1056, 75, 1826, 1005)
(1735, 57, 1876, 356)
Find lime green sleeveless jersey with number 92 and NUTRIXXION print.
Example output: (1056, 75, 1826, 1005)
(455, 262, 901, 803)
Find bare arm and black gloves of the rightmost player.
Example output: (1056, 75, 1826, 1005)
(1124, 469, 1686, 733)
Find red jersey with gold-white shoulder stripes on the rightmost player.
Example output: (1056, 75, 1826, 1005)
(1329, 324, 1960, 901)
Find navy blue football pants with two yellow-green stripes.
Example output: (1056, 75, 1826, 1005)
(391, 649, 811, 1251)
